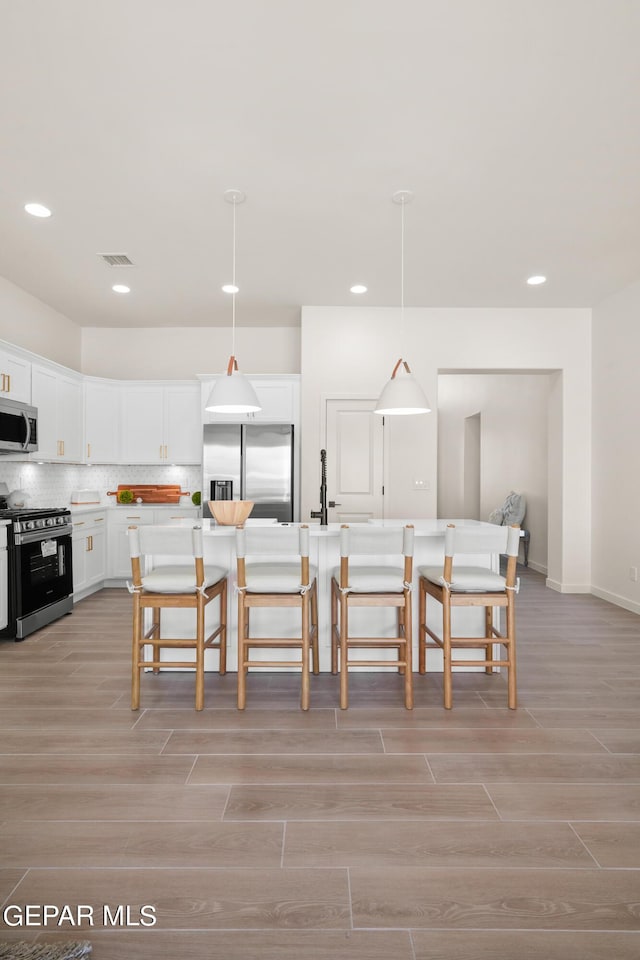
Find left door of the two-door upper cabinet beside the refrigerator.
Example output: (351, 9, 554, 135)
(121, 385, 167, 463)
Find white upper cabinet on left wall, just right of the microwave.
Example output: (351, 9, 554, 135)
(31, 363, 83, 463)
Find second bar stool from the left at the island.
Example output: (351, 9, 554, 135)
(236, 524, 320, 710)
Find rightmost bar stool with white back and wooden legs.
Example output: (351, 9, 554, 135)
(418, 523, 520, 710)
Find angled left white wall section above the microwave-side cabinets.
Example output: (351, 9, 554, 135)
(0, 277, 82, 370)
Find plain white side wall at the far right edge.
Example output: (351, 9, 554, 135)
(592, 283, 640, 613)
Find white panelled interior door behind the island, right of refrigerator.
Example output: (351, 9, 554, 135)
(326, 399, 384, 523)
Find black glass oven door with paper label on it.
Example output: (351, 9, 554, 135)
(11, 528, 73, 620)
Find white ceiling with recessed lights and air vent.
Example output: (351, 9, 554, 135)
(0, 0, 640, 327)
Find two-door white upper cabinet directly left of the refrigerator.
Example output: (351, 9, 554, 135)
(121, 383, 202, 464)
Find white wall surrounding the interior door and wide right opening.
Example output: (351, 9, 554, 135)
(300, 307, 591, 592)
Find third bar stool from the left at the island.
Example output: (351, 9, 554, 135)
(331, 524, 414, 710)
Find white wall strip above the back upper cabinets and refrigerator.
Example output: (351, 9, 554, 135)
(82, 327, 300, 380)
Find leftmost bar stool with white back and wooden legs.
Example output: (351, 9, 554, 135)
(127, 525, 227, 710)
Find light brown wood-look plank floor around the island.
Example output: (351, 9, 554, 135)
(0, 568, 640, 960)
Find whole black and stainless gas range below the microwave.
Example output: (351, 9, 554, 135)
(0, 509, 73, 640)
